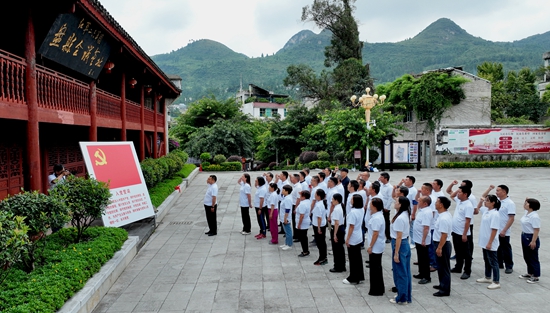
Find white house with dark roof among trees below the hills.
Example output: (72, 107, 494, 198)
(237, 84, 289, 119)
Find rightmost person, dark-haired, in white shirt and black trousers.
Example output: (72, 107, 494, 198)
(519, 198, 540, 284)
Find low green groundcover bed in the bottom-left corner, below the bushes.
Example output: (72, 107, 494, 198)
(0, 227, 128, 313)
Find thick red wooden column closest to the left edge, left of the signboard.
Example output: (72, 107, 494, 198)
(25, 7, 44, 192)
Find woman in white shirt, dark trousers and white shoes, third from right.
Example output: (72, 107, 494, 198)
(476, 195, 501, 290)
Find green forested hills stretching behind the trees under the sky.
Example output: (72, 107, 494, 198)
(152, 18, 550, 102)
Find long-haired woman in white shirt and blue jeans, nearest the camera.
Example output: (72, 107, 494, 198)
(390, 196, 412, 304)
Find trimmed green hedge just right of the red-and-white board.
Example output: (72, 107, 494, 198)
(140, 150, 189, 188)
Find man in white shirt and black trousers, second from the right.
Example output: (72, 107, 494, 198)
(496, 185, 516, 274)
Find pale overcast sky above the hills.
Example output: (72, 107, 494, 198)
(100, 0, 550, 57)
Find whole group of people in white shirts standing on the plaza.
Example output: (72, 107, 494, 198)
(205, 168, 541, 304)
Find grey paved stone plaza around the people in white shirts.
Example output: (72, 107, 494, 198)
(94, 168, 550, 313)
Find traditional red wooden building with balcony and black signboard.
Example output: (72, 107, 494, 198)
(0, 0, 181, 199)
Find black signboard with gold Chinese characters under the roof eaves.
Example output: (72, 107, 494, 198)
(38, 14, 111, 79)
